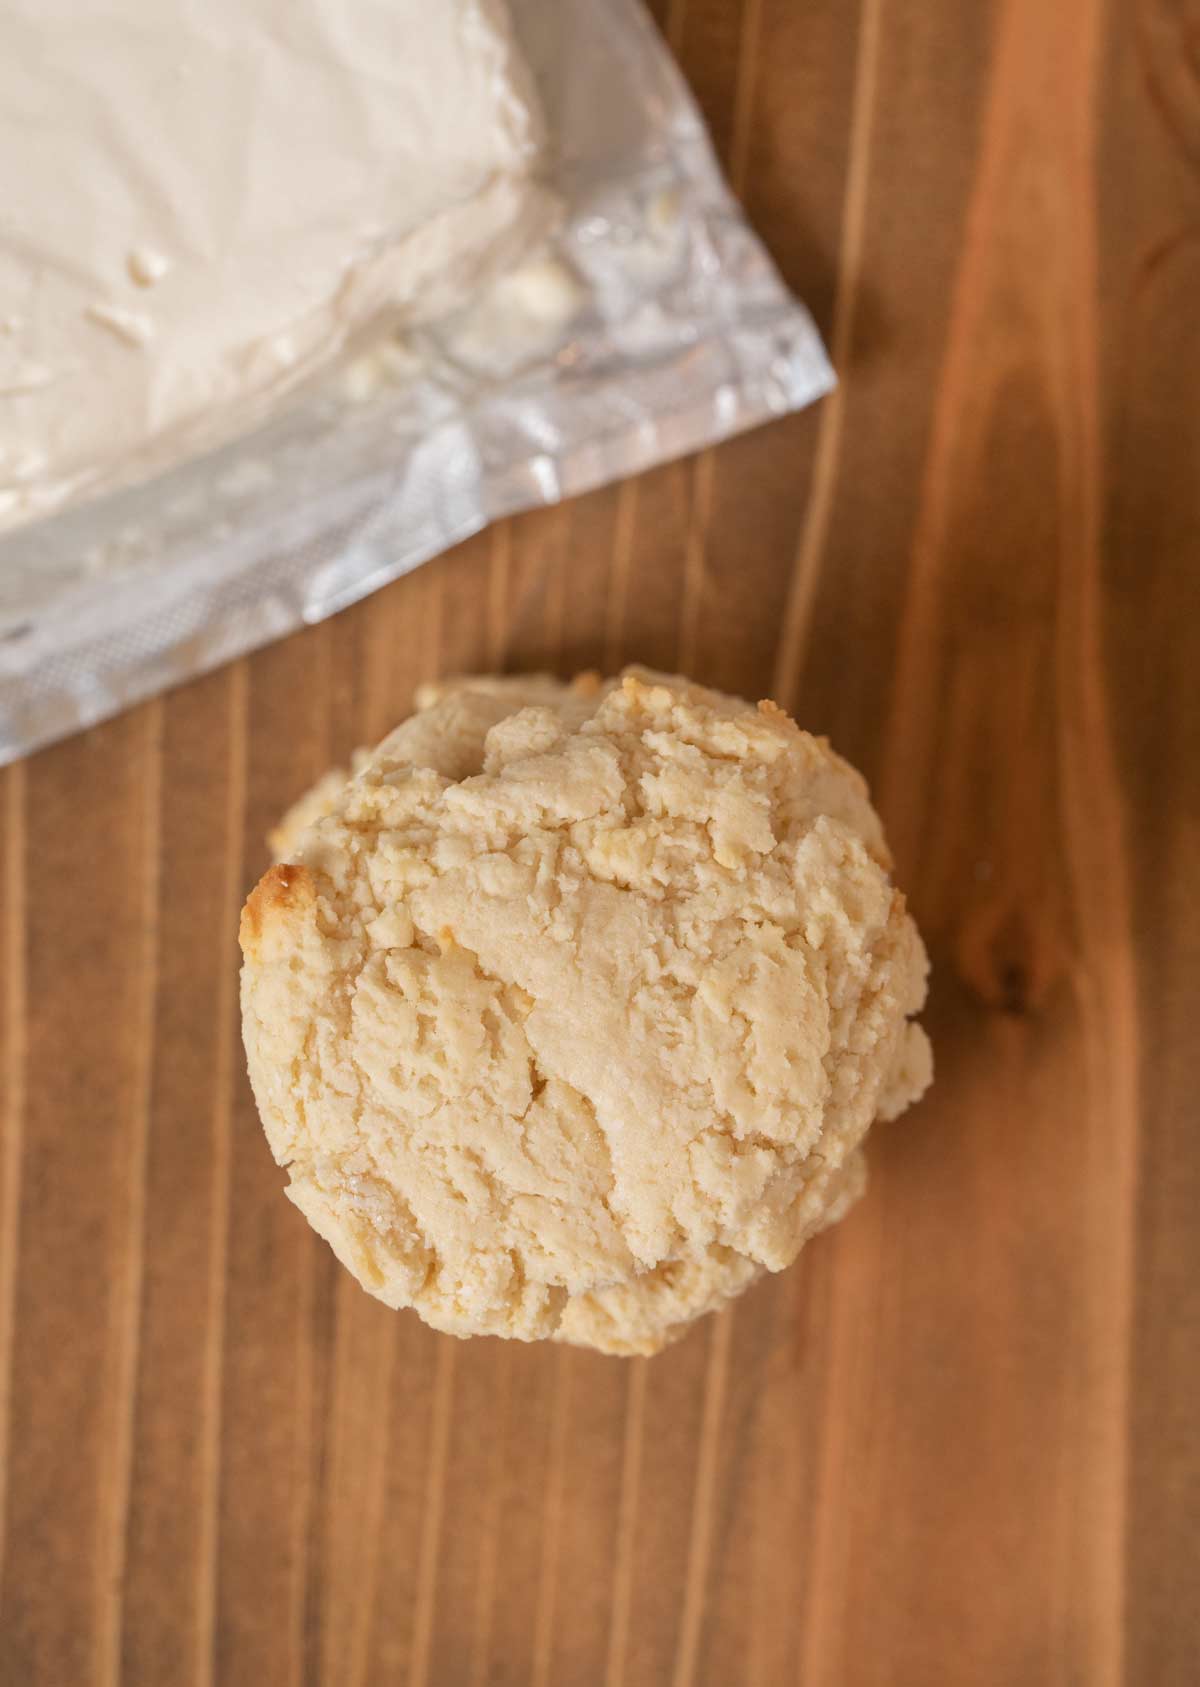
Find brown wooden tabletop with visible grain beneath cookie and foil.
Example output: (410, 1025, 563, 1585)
(0, 0, 1200, 1687)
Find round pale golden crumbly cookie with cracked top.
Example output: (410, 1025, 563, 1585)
(241, 670, 932, 1353)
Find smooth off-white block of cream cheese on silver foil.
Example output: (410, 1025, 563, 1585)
(0, 0, 543, 526)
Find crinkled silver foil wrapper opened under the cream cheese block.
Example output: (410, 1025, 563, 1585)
(0, 0, 834, 763)
